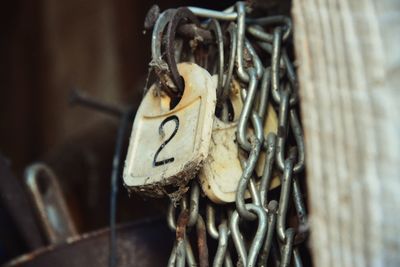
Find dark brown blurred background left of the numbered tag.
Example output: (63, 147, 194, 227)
(0, 0, 289, 264)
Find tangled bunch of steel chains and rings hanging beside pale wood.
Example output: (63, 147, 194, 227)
(150, 2, 307, 266)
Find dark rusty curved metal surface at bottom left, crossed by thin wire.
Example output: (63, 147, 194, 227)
(4, 220, 173, 267)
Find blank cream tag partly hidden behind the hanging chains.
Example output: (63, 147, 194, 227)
(199, 80, 280, 203)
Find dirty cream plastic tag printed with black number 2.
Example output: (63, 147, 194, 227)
(123, 63, 216, 199)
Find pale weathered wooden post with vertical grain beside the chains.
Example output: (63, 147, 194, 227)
(293, 0, 400, 267)
